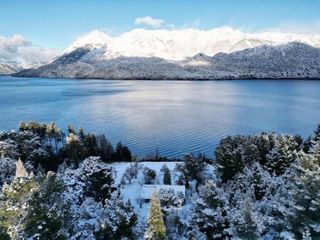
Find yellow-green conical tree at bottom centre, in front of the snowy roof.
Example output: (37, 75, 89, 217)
(145, 193, 166, 240)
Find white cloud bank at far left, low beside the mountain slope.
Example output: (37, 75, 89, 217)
(0, 34, 59, 68)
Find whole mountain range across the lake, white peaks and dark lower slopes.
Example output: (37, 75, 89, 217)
(5, 27, 320, 80)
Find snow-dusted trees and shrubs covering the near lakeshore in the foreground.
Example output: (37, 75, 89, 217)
(0, 122, 320, 239)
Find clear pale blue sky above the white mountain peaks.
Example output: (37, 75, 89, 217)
(0, 0, 320, 49)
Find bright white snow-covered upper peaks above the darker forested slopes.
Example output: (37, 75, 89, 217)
(64, 27, 320, 60)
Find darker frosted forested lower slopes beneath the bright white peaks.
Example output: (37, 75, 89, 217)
(17, 42, 320, 80)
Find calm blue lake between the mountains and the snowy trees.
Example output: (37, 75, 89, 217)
(0, 77, 320, 156)
